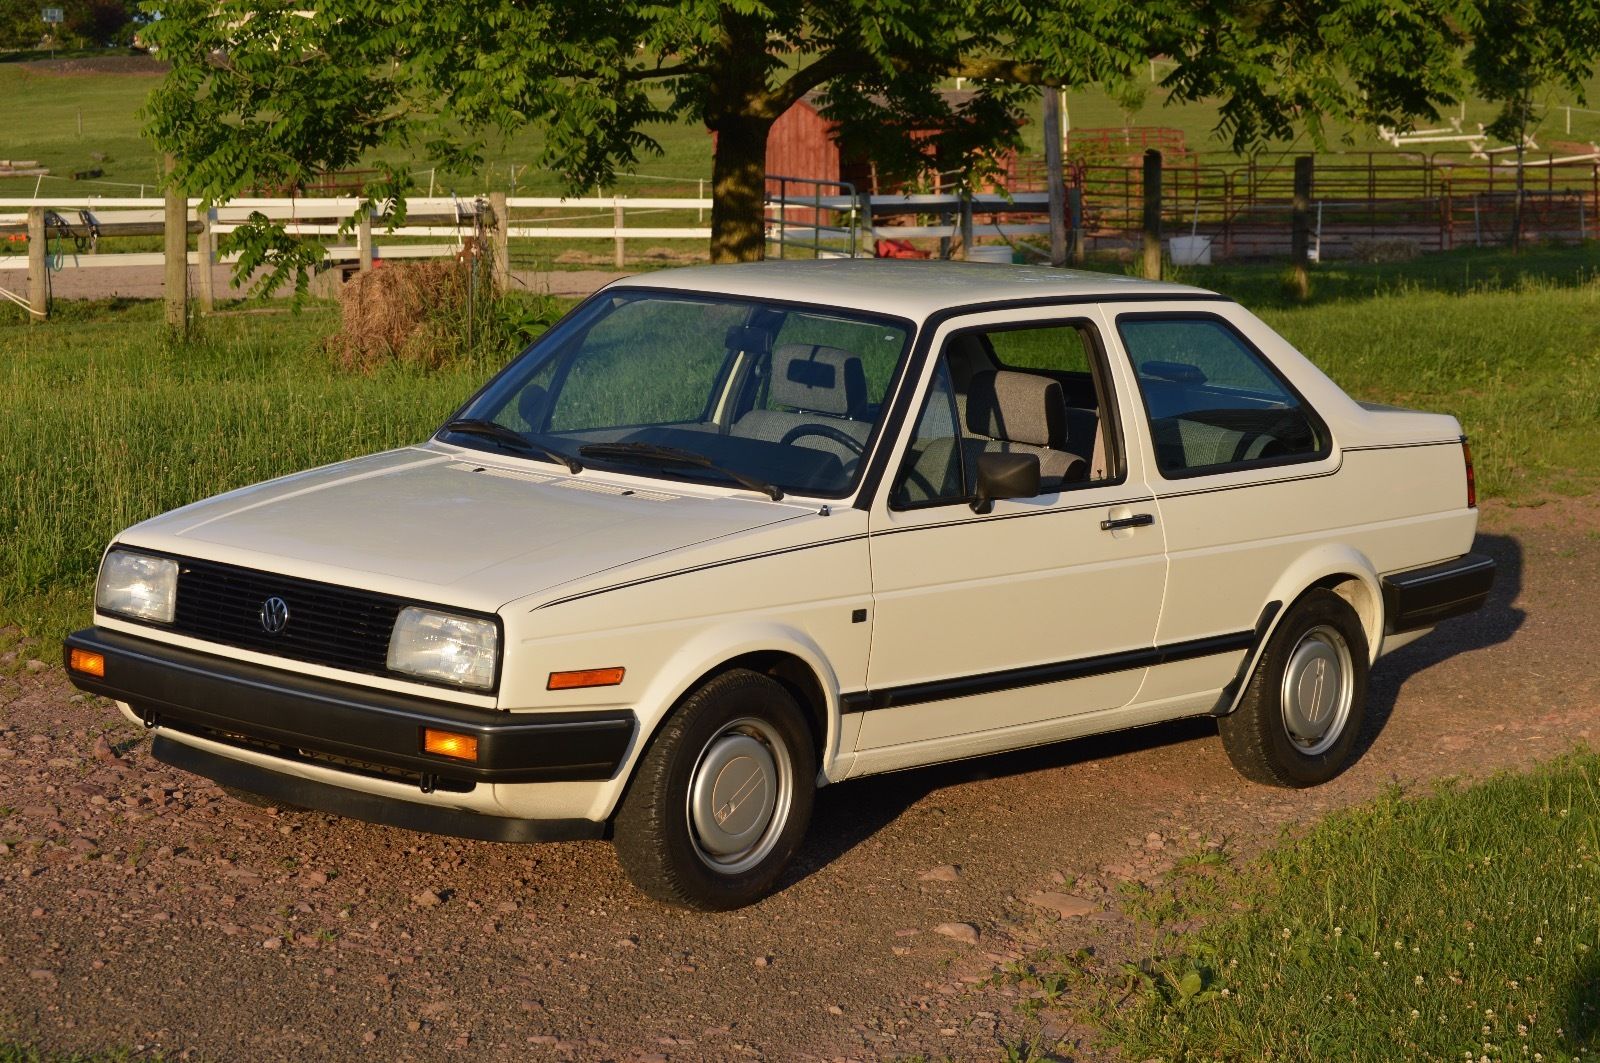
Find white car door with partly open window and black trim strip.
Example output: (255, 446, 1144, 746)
(846, 306, 1166, 770)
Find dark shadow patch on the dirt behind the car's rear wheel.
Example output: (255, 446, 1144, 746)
(1355, 535, 1528, 757)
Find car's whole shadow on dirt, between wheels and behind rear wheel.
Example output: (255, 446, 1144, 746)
(779, 535, 1526, 889)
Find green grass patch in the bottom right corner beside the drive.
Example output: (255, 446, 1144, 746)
(1094, 752, 1600, 1063)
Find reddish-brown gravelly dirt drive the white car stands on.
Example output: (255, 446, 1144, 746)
(0, 501, 1600, 1060)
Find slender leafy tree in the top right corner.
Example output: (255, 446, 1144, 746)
(1467, 0, 1600, 250)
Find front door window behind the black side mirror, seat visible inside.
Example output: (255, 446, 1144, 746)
(890, 322, 1117, 507)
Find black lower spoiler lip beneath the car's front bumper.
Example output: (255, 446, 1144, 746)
(150, 735, 606, 842)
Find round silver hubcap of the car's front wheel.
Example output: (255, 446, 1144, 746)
(688, 717, 794, 874)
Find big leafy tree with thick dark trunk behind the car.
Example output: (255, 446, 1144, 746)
(137, 0, 1587, 286)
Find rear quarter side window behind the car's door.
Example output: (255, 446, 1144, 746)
(1117, 315, 1328, 477)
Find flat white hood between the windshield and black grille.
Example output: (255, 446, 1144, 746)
(122, 448, 810, 610)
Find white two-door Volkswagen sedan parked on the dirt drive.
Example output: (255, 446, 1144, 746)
(66, 261, 1494, 908)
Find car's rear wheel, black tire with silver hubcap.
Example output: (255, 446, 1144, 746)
(1218, 588, 1368, 788)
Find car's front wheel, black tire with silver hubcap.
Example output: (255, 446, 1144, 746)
(613, 669, 816, 911)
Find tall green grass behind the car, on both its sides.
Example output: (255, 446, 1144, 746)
(0, 248, 1600, 639)
